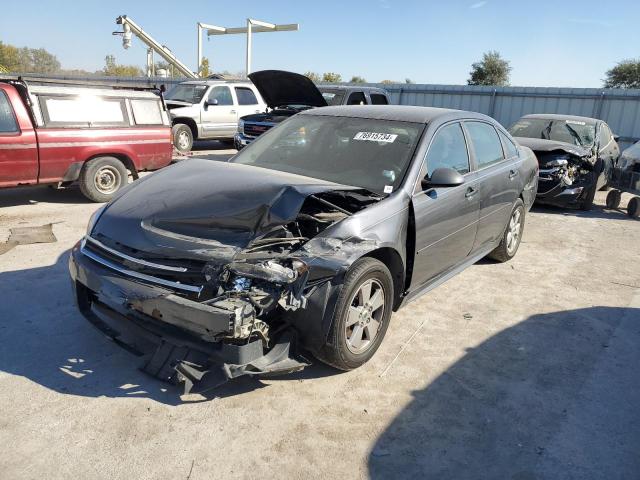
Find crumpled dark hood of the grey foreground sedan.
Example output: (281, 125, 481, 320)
(92, 159, 354, 258)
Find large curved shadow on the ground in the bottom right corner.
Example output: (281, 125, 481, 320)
(368, 307, 640, 480)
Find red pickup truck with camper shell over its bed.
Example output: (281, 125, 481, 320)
(0, 79, 172, 202)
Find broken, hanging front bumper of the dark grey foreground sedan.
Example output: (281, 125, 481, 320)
(69, 242, 309, 393)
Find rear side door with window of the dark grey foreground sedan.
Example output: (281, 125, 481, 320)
(463, 121, 520, 251)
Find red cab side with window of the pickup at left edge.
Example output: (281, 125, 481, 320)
(0, 86, 38, 187)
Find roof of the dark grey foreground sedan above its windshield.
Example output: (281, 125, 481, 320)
(298, 105, 496, 123)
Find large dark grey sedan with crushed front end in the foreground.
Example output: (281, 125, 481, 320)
(70, 106, 537, 390)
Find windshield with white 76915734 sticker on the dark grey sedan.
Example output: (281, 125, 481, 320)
(230, 115, 424, 195)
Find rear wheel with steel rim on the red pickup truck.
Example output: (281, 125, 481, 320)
(78, 157, 129, 202)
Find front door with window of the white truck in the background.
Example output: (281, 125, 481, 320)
(200, 85, 238, 138)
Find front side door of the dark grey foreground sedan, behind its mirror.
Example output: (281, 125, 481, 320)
(412, 122, 480, 289)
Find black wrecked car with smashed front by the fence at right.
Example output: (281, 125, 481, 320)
(509, 114, 620, 210)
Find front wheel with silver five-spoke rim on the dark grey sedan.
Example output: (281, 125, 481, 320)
(316, 257, 393, 370)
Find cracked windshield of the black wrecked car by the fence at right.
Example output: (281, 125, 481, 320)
(509, 118, 596, 147)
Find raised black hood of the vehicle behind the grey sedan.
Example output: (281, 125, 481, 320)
(249, 70, 327, 108)
